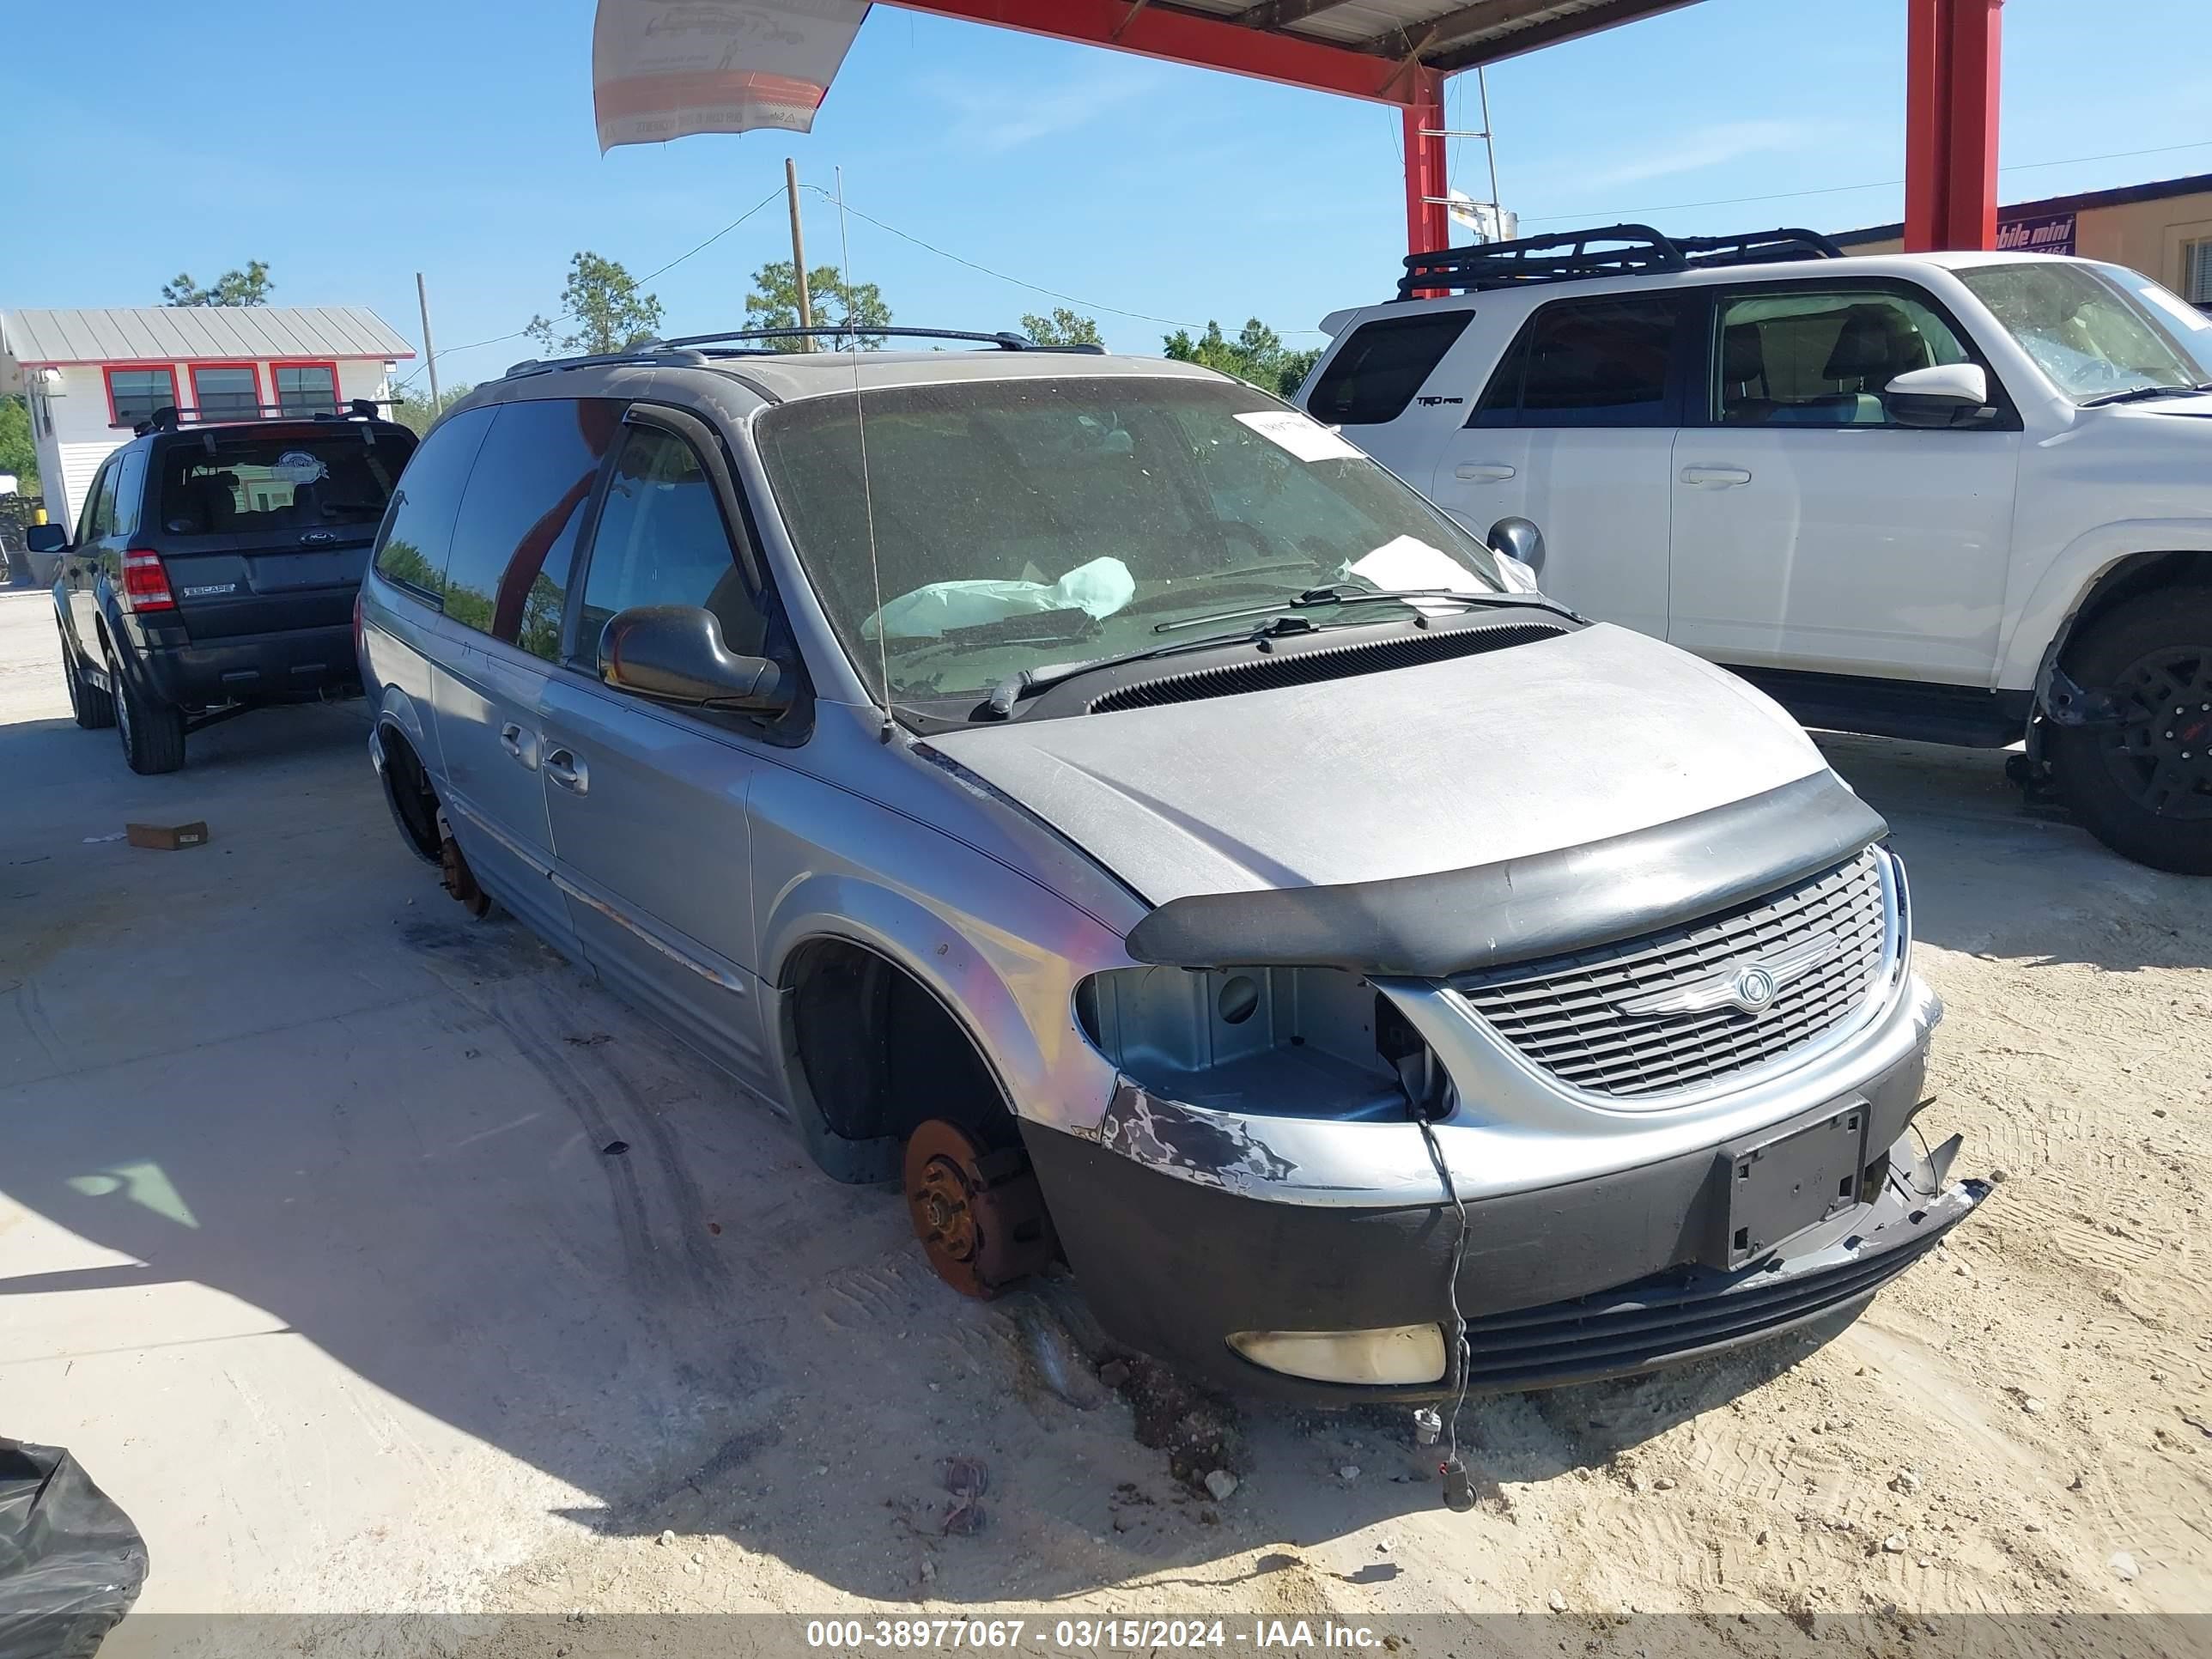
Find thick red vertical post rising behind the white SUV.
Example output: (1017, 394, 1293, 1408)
(1905, 0, 2004, 252)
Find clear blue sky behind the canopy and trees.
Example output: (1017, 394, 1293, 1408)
(0, 0, 2212, 383)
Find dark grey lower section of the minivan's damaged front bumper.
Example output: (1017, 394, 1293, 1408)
(1024, 1110, 1990, 1405)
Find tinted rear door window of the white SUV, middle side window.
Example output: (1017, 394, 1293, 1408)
(1468, 299, 1681, 427)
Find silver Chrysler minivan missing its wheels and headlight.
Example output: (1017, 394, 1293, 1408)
(358, 337, 1989, 1402)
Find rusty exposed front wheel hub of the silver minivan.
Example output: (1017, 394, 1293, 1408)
(905, 1117, 1057, 1297)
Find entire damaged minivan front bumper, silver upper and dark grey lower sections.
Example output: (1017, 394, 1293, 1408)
(1022, 964, 1989, 1402)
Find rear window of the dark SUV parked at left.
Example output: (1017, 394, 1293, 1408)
(161, 427, 414, 535)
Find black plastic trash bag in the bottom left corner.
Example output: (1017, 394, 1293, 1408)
(0, 1440, 146, 1659)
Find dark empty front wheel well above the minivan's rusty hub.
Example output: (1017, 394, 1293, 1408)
(783, 940, 1018, 1179)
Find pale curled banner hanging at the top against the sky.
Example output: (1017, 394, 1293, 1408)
(591, 0, 867, 155)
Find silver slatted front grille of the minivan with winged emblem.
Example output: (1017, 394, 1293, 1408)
(1453, 848, 1889, 1097)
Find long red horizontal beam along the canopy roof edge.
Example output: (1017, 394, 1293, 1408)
(896, 0, 1407, 106)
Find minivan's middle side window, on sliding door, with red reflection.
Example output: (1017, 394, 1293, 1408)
(445, 398, 622, 661)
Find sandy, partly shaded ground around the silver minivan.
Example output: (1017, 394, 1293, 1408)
(0, 592, 2212, 1646)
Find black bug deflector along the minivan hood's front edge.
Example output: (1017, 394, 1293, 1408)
(1128, 768, 1889, 980)
